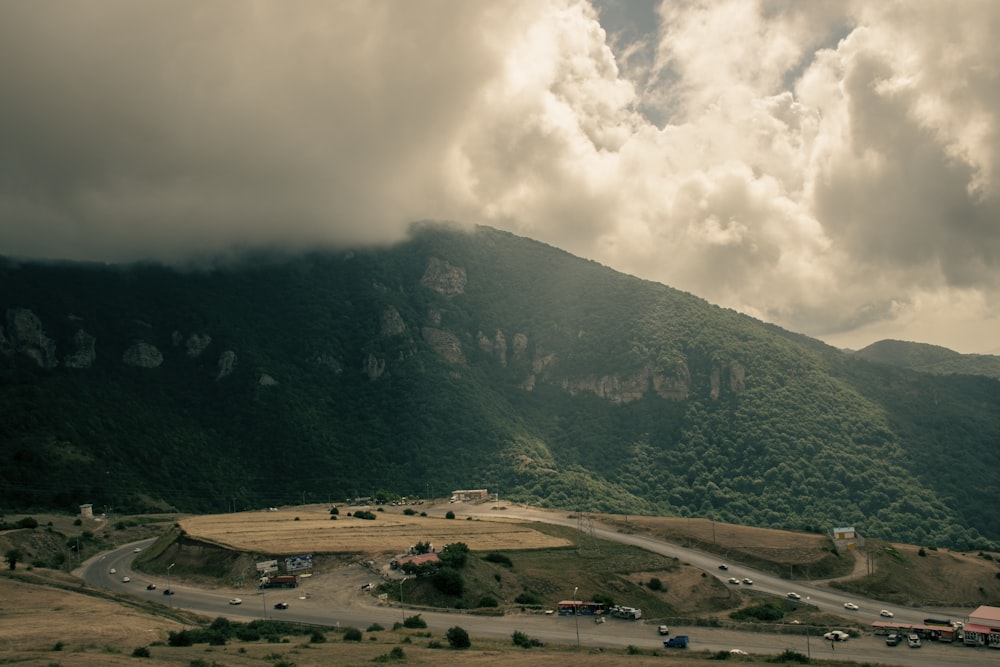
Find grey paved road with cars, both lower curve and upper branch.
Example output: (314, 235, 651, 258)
(76, 506, 988, 667)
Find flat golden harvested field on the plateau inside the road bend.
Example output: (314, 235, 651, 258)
(179, 505, 571, 555)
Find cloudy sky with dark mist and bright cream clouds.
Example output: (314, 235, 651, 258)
(0, 0, 1000, 353)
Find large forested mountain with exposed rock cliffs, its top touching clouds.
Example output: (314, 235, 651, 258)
(0, 225, 1000, 548)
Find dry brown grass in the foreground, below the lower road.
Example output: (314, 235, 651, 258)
(0, 569, 849, 667)
